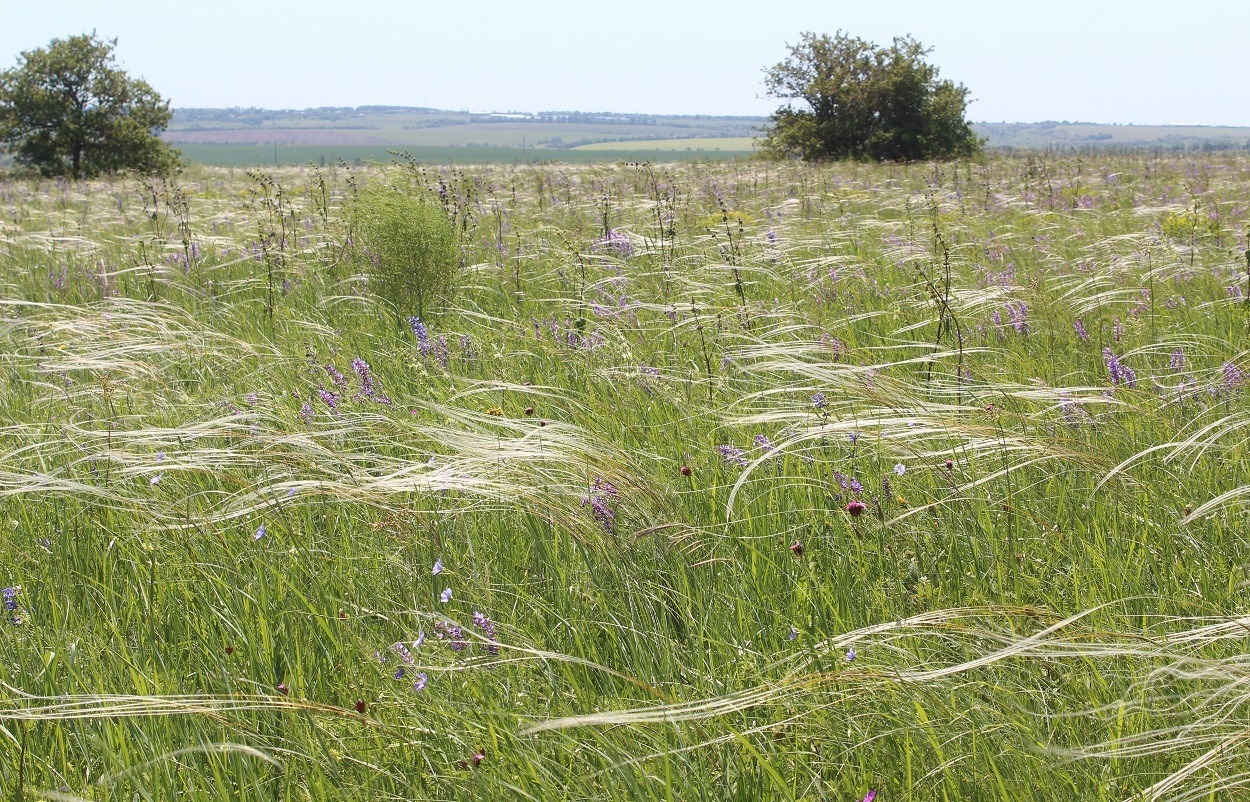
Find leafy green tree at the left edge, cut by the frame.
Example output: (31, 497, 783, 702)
(0, 32, 178, 179)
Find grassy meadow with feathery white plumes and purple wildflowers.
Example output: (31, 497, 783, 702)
(0, 151, 1250, 802)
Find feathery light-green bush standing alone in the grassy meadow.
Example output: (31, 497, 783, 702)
(351, 177, 459, 317)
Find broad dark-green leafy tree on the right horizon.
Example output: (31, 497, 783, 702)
(763, 31, 981, 161)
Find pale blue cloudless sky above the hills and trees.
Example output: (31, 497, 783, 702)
(0, 0, 1250, 126)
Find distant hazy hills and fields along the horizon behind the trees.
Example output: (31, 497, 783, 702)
(164, 106, 1250, 165)
